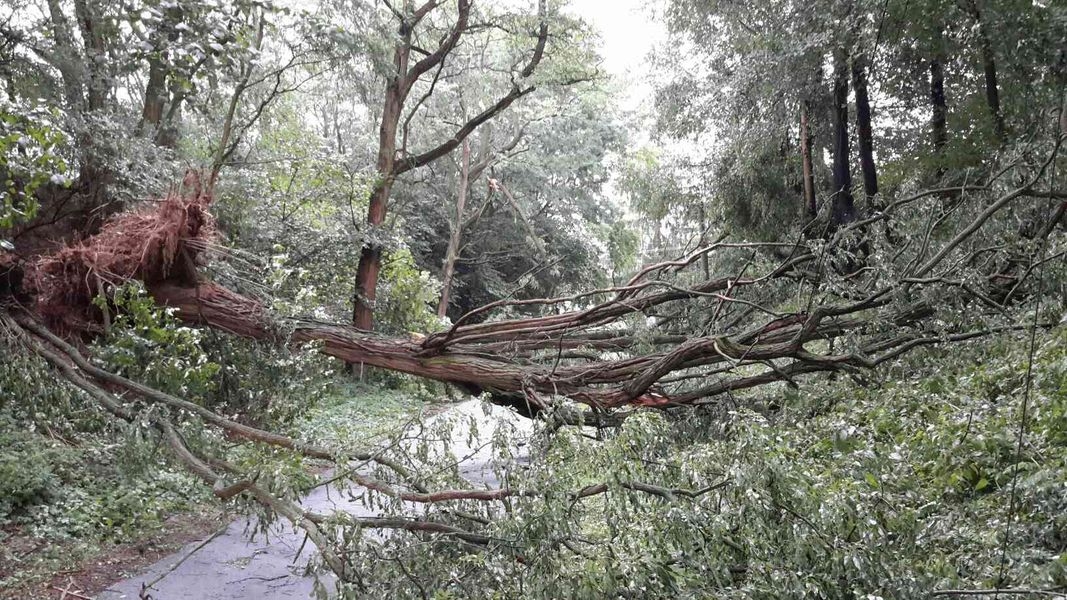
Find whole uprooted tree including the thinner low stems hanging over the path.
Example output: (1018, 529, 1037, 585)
(0, 122, 1067, 581)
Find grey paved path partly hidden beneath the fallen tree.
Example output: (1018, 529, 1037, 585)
(97, 400, 529, 600)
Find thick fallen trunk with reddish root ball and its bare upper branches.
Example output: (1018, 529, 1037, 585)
(9, 149, 1054, 413)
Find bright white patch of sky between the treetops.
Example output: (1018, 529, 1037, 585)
(569, 0, 667, 110)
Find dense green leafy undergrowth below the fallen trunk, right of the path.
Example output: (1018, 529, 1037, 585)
(324, 329, 1067, 598)
